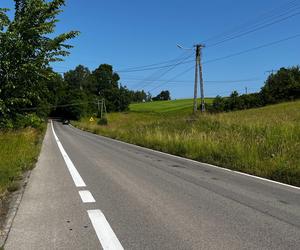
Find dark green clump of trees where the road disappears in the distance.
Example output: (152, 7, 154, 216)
(51, 64, 151, 119)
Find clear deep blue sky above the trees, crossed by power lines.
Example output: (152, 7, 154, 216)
(0, 0, 300, 98)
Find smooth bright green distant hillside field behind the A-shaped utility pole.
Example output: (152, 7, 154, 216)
(130, 98, 213, 113)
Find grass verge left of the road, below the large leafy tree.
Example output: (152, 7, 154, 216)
(0, 128, 44, 198)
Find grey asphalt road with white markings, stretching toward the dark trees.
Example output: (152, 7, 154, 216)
(5, 122, 300, 250)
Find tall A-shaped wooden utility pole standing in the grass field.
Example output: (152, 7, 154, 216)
(193, 44, 205, 114)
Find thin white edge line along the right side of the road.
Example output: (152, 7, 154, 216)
(70, 124, 300, 190)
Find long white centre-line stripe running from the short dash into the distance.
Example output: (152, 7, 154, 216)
(51, 120, 86, 187)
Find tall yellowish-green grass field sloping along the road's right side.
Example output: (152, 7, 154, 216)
(74, 101, 300, 186)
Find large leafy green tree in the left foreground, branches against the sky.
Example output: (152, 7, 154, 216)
(0, 0, 78, 126)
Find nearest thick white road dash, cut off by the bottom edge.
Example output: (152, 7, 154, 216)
(87, 209, 124, 250)
